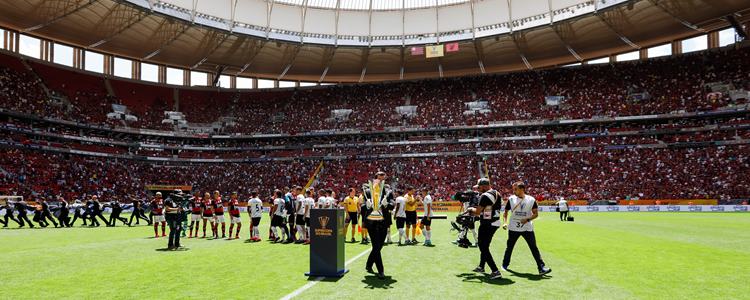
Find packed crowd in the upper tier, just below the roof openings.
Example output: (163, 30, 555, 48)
(0, 49, 750, 133)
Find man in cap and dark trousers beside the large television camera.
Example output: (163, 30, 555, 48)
(467, 178, 503, 279)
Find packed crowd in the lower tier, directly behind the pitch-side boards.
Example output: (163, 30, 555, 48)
(0, 145, 750, 201)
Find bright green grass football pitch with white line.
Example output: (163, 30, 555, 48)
(0, 213, 750, 299)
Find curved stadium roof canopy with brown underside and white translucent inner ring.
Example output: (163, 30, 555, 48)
(0, 0, 750, 82)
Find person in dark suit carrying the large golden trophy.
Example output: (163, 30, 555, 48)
(362, 172, 393, 279)
